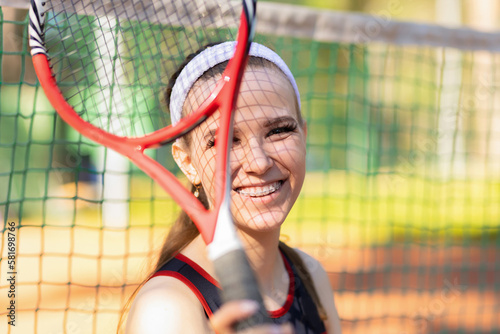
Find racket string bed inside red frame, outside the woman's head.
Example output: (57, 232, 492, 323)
(38, 0, 238, 137)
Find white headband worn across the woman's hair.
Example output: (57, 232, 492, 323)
(170, 42, 300, 125)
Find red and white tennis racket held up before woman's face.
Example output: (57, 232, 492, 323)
(29, 0, 269, 329)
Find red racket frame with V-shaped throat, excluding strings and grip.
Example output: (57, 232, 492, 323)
(29, 0, 256, 245)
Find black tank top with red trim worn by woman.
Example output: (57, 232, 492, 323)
(151, 253, 326, 334)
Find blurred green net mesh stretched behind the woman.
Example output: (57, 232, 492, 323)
(0, 1, 500, 333)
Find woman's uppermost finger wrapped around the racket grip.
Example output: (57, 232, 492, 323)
(210, 300, 259, 334)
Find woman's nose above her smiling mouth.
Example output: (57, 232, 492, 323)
(238, 140, 273, 175)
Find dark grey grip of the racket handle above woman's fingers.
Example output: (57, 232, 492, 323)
(213, 249, 271, 332)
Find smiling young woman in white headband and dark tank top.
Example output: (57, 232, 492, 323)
(126, 42, 340, 334)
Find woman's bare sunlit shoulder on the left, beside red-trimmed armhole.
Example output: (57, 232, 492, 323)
(125, 276, 211, 334)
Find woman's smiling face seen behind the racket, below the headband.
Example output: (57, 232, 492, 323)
(173, 59, 306, 231)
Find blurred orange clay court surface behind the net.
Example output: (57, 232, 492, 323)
(0, 227, 500, 334)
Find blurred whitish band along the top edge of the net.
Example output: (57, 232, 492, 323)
(5, 0, 500, 52)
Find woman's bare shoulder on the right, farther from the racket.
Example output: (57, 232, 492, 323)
(294, 248, 341, 334)
